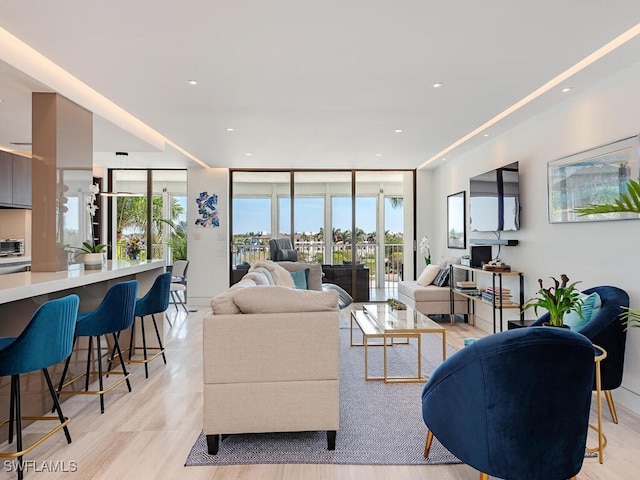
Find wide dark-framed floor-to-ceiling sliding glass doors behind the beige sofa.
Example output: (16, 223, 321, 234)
(231, 170, 414, 300)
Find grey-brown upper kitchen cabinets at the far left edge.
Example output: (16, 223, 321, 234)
(0, 151, 31, 208)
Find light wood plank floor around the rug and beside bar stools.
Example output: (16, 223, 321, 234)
(0, 307, 640, 480)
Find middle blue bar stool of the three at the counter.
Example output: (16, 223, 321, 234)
(58, 280, 138, 413)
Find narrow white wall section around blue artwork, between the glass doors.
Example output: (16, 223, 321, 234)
(187, 168, 230, 308)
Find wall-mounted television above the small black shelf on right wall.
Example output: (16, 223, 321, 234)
(469, 162, 520, 232)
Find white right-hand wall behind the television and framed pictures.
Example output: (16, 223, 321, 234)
(418, 59, 640, 413)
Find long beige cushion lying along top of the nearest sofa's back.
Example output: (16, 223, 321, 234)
(233, 285, 338, 313)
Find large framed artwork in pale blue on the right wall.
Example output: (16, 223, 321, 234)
(547, 135, 640, 223)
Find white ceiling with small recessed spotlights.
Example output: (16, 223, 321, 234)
(0, 0, 640, 169)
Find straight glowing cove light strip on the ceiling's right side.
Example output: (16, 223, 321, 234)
(417, 23, 640, 170)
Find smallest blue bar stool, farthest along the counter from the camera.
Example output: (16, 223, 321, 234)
(129, 272, 171, 378)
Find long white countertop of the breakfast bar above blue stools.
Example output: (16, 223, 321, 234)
(0, 260, 165, 304)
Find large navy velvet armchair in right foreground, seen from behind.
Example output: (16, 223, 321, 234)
(422, 328, 596, 480)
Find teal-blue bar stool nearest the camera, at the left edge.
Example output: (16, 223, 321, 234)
(0, 295, 80, 480)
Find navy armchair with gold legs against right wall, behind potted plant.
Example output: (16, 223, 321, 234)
(531, 286, 629, 423)
